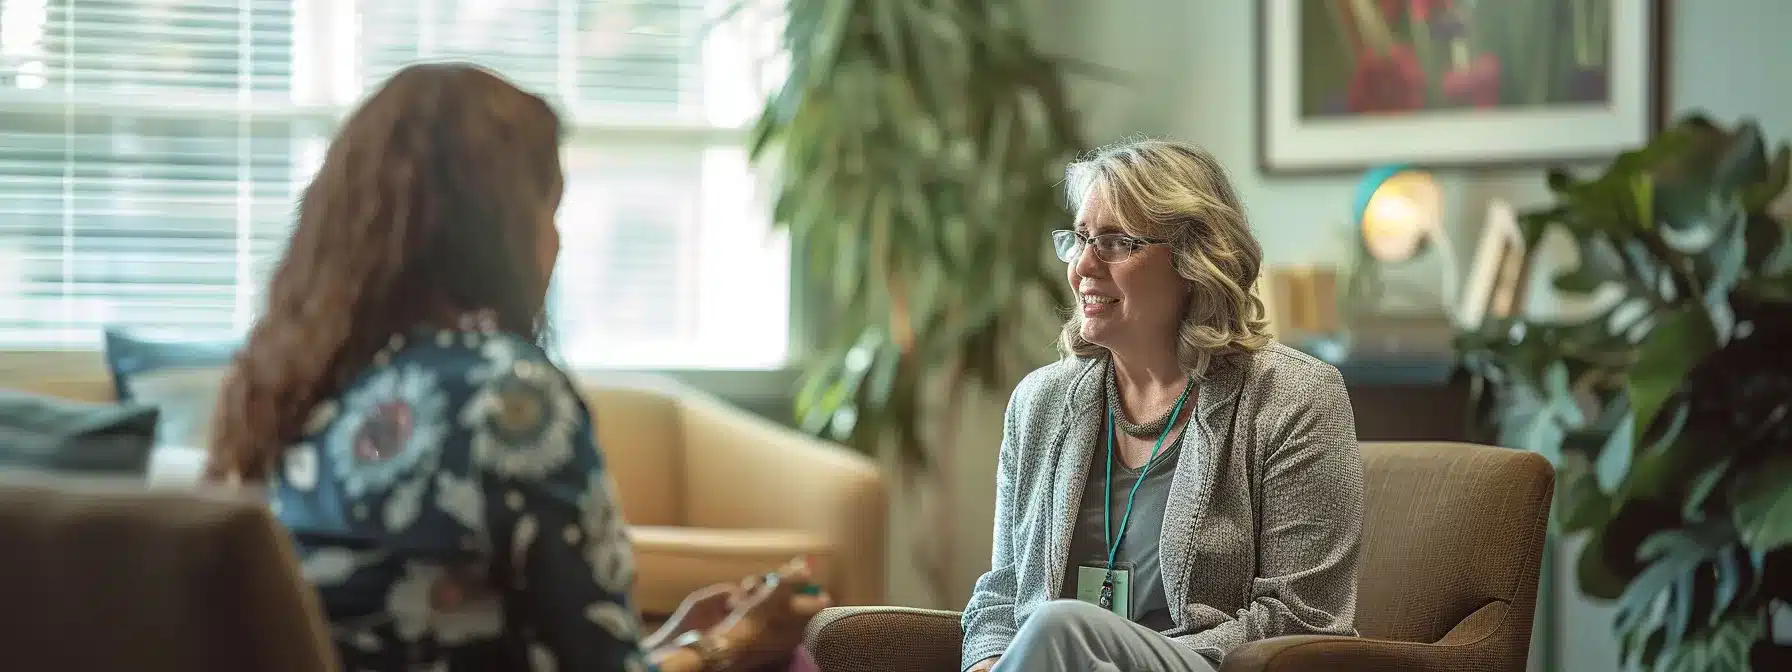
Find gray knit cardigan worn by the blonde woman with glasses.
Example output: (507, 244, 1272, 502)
(962, 344, 1364, 667)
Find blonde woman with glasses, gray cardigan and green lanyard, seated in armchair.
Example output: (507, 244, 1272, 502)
(962, 140, 1364, 672)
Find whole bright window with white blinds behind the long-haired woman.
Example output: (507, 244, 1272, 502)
(0, 0, 788, 367)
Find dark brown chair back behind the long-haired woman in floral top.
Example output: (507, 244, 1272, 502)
(0, 475, 335, 672)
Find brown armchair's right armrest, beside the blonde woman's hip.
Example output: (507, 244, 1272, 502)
(1220, 602, 1530, 672)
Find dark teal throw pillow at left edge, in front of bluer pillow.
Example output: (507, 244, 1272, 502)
(0, 391, 156, 475)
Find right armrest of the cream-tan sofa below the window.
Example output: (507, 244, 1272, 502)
(679, 392, 889, 606)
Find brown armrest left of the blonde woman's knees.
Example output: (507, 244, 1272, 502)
(805, 607, 964, 672)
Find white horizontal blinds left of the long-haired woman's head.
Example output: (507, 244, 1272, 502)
(0, 0, 301, 348)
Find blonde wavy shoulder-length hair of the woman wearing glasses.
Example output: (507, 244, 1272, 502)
(1059, 140, 1271, 380)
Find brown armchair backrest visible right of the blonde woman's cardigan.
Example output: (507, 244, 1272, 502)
(1357, 443, 1555, 642)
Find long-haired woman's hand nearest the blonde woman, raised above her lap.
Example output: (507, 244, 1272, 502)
(713, 561, 831, 670)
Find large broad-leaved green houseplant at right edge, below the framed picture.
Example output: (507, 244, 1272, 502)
(1459, 116, 1792, 670)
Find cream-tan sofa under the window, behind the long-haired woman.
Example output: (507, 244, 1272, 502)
(0, 375, 887, 615)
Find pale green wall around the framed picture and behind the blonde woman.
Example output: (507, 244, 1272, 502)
(910, 0, 1792, 670)
